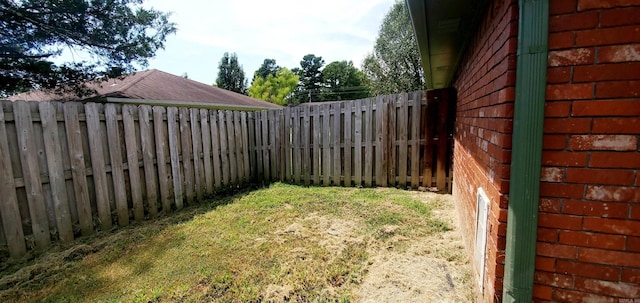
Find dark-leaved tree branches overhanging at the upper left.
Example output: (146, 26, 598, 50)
(0, 0, 176, 95)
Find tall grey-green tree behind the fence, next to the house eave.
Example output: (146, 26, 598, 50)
(362, 1, 424, 95)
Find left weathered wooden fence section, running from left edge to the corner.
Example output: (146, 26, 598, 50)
(0, 102, 252, 256)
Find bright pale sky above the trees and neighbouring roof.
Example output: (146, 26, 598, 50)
(139, 0, 395, 84)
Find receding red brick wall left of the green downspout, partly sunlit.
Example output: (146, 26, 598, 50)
(453, 0, 518, 302)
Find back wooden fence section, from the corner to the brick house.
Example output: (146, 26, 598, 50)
(249, 91, 451, 190)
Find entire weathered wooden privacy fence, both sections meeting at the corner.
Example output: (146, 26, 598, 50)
(0, 92, 451, 257)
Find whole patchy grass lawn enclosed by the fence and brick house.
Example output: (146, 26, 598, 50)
(0, 183, 473, 302)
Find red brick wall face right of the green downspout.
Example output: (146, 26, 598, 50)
(534, 0, 640, 302)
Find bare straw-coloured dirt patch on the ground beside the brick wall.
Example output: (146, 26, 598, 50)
(356, 193, 474, 303)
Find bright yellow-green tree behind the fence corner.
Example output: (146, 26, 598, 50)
(249, 67, 300, 105)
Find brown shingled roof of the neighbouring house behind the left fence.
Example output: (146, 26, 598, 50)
(8, 69, 280, 109)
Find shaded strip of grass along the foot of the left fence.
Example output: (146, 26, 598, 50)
(0, 185, 260, 302)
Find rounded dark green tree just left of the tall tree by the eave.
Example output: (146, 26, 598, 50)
(321, 61, 370, 101)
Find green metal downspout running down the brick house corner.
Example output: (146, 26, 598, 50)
(502, 0, 549, 302)
